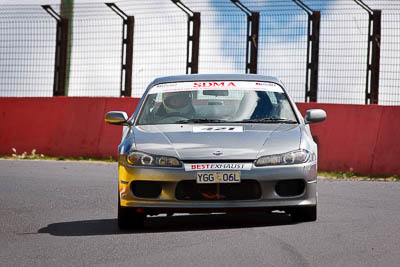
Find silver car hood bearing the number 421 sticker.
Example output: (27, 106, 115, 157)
(133, 124, 301, 160)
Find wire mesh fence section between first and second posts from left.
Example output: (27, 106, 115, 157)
(68, 17, 122, 97)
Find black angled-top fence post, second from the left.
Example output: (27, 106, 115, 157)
(105, 3, 135, 97)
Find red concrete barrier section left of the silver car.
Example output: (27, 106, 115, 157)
(0, 97, 139, 157)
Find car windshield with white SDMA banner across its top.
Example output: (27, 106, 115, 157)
(136, 81, 298, 125)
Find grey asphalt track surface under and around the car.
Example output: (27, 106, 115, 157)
(0, 160, 400, 266)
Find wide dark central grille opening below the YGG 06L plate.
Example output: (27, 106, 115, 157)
(175, 180, 261, 201)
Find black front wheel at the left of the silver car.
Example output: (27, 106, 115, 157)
(118, 196, 146, 230)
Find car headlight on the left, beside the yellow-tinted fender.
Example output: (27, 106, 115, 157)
(126, 151, 182, 167)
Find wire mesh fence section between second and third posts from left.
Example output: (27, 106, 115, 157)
(132, 15, 187, 97)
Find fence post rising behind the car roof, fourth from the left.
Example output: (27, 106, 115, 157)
(231, 0, 260, 74)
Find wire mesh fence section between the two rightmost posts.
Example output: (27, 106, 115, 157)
(318, 11, 368, 104)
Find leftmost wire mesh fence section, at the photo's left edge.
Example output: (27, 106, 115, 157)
(0, 6, 56, 97)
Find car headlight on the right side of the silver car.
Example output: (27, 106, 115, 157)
(254, 149, 315, 166)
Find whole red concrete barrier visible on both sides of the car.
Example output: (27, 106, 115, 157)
(0, 97, 400, 174)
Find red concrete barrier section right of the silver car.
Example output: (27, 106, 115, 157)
(297, 103, 400, 174)
